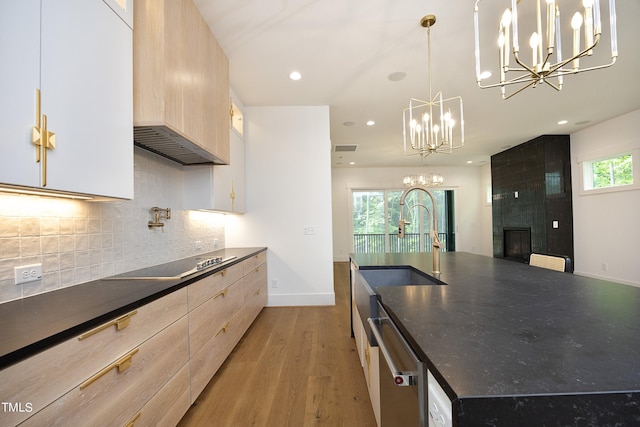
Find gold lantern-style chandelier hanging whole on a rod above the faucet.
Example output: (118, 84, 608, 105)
(402, 15, 464, 158)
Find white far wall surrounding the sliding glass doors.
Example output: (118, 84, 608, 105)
(332, 166, 493, 261)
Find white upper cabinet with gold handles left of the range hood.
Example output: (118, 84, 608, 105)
(0, 0, 133, 198)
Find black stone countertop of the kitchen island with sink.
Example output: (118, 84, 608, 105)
(351, 252, 640, 426)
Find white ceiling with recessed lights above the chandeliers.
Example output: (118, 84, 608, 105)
(195, 0, 640, 167)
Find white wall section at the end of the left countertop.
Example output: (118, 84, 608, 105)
(225, 106, 335, 306)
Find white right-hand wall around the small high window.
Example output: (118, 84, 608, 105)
(571, 110, 640, 286)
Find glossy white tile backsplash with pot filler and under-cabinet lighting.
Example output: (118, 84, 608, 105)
(0, 148, 225, 303)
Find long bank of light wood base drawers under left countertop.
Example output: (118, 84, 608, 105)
(0, 251, 267, 426)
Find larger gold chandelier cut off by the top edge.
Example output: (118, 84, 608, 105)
(474, 0, 618, 99)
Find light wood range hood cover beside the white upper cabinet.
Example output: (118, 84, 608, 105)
(133, 0, 229, 164)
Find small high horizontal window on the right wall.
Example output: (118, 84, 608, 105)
(582, 153, 633, 190)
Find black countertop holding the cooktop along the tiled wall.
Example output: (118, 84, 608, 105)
(0, 248, 266, 369)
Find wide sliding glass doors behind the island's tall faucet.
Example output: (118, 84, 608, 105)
(352, 189, 455, 253)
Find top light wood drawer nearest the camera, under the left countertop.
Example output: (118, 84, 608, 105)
(0, 289, 187, 425)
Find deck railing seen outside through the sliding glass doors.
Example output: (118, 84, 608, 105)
(353, 233, 447, 253)
